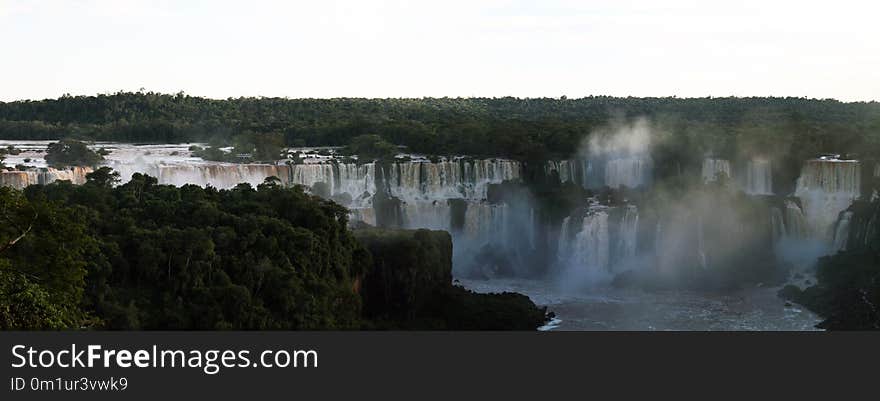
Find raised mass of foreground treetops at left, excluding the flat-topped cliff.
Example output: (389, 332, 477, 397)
(0, 175, 365, 329)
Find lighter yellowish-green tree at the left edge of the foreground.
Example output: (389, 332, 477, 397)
(0, 184, 96, 329)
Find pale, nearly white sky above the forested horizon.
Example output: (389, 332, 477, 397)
(0, 0, 880, 101)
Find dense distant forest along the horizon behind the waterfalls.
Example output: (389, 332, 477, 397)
(0, 92, 880, 160)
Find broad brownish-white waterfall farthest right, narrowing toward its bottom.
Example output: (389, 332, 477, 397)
(795, 159, 861, 243)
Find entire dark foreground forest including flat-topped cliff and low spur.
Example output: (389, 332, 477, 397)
(0, 167, 545, 330)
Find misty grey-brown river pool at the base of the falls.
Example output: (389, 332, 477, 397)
(460, 279, 820, 331)
